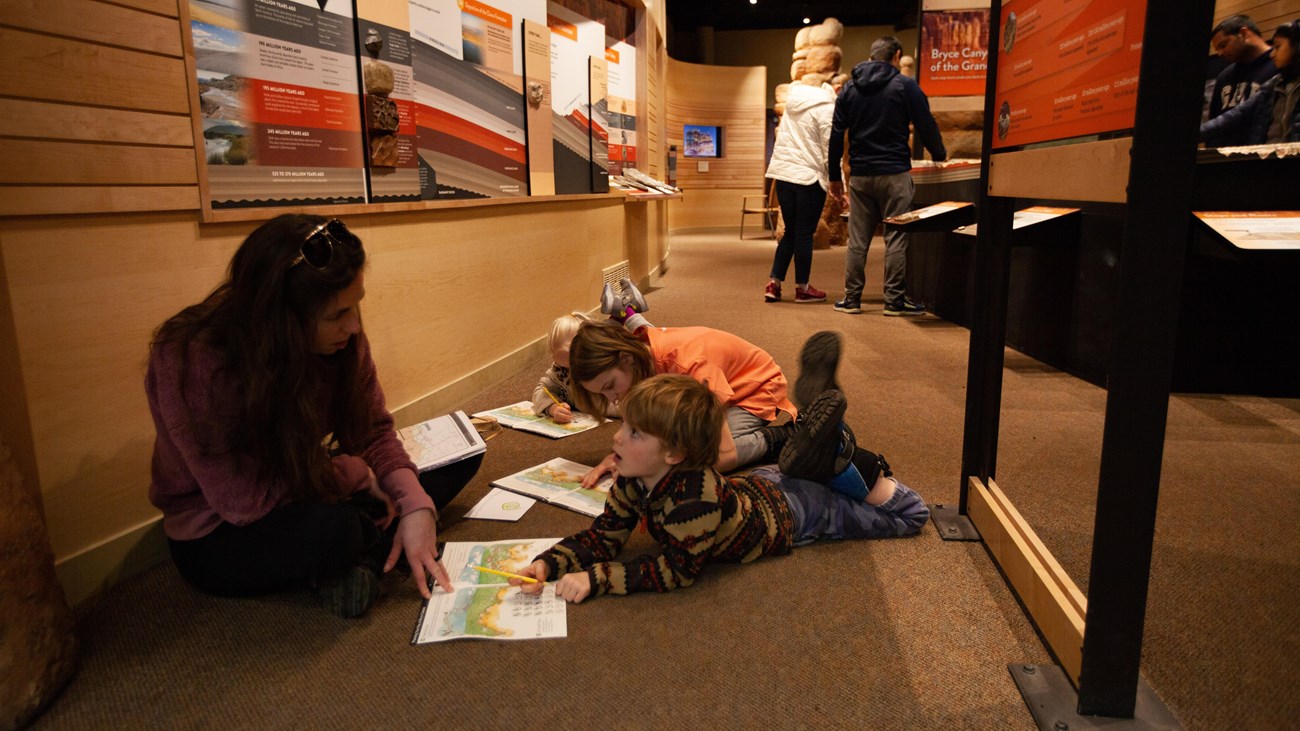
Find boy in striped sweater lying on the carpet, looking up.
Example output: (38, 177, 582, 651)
(511, 375, 930, 602)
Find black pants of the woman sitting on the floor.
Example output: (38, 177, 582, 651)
(168, 454, 484, 597)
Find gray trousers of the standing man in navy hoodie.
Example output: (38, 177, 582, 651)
(844, 173, 917, 304)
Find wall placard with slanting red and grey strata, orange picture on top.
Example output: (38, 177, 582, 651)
(410, 0, 535, 200)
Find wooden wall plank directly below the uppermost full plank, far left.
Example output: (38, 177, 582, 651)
(0, 29, 190, 114)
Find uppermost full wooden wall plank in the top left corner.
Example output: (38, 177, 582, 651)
(4, 0, 181, 59)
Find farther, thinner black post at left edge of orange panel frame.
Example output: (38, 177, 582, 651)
(961, 0, 1015, 515)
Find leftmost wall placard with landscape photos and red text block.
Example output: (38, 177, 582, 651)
(190, 0, 365, 208)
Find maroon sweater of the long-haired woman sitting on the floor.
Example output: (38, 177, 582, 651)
(144, 334, 433, 541)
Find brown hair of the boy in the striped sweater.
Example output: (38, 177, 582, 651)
(623, 373, 727, 470)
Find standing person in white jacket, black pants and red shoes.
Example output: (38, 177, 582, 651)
(763, 82, 835, 303)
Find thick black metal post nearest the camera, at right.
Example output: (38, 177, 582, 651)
(1079, 0, 1214, 718)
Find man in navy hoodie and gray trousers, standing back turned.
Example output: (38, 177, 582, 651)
(827, 35, 948, 315)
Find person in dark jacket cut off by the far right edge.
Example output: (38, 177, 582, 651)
(1201, 20, 1300, 144)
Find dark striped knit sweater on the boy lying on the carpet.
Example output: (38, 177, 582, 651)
(537, 468, 794, 596)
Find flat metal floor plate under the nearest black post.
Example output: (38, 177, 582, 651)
(1006, 662, 1183, 731)
